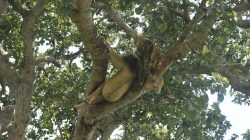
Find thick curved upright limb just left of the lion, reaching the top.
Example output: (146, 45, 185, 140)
(70, 0, 108, 95)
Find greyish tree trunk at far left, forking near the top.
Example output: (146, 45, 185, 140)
(0, 0, 47, 140)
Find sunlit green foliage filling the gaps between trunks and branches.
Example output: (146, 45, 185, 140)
(0, 0, 250, 140)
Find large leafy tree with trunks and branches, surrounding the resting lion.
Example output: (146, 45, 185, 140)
(0, 0, 250, 140)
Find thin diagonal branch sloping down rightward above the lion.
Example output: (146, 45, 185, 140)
(93, 2, 140, 41)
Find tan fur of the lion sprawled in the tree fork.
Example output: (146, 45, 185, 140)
(75, 46, 164, 112)
